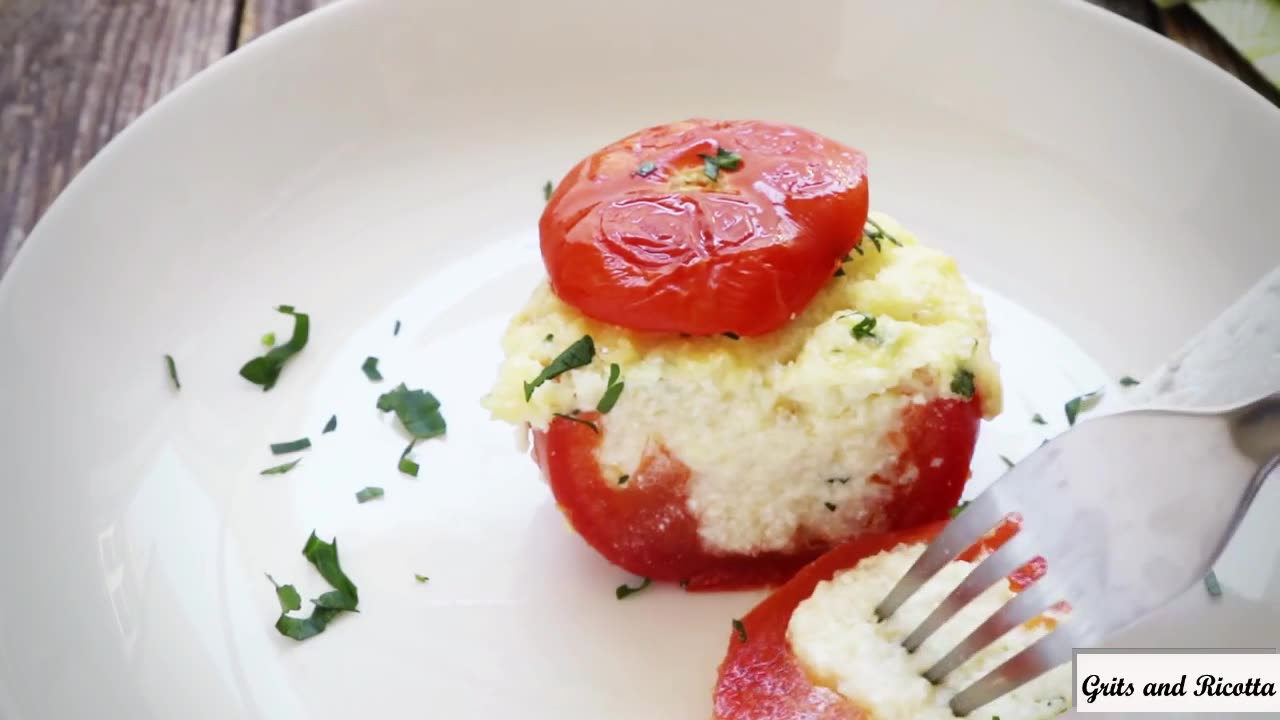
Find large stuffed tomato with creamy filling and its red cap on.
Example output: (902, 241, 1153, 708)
(485, 120, 1001, 589)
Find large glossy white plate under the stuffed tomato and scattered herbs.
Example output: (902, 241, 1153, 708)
(0, 0, 1280, 720)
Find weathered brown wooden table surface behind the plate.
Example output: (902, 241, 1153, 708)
(0, 0, 1280, 272)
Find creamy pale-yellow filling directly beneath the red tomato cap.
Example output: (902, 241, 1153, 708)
(484, 213, 1001, 553)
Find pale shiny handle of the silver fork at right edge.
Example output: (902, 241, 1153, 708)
(1133, 268, 1280, 410)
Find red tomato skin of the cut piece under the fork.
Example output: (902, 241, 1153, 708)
(713, 521, 1043, 720)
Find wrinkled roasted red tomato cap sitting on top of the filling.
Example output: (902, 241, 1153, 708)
(539, 119, 869, 336)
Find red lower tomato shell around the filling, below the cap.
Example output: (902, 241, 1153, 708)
(534, 397, 982, 591)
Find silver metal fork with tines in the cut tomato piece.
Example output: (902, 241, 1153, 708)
(876, 269, 1280, 716)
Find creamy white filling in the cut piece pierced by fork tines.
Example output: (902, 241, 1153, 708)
(787, 544, 1071, 720)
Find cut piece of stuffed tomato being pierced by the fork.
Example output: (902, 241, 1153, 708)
(713, 523, 1071, 720)
